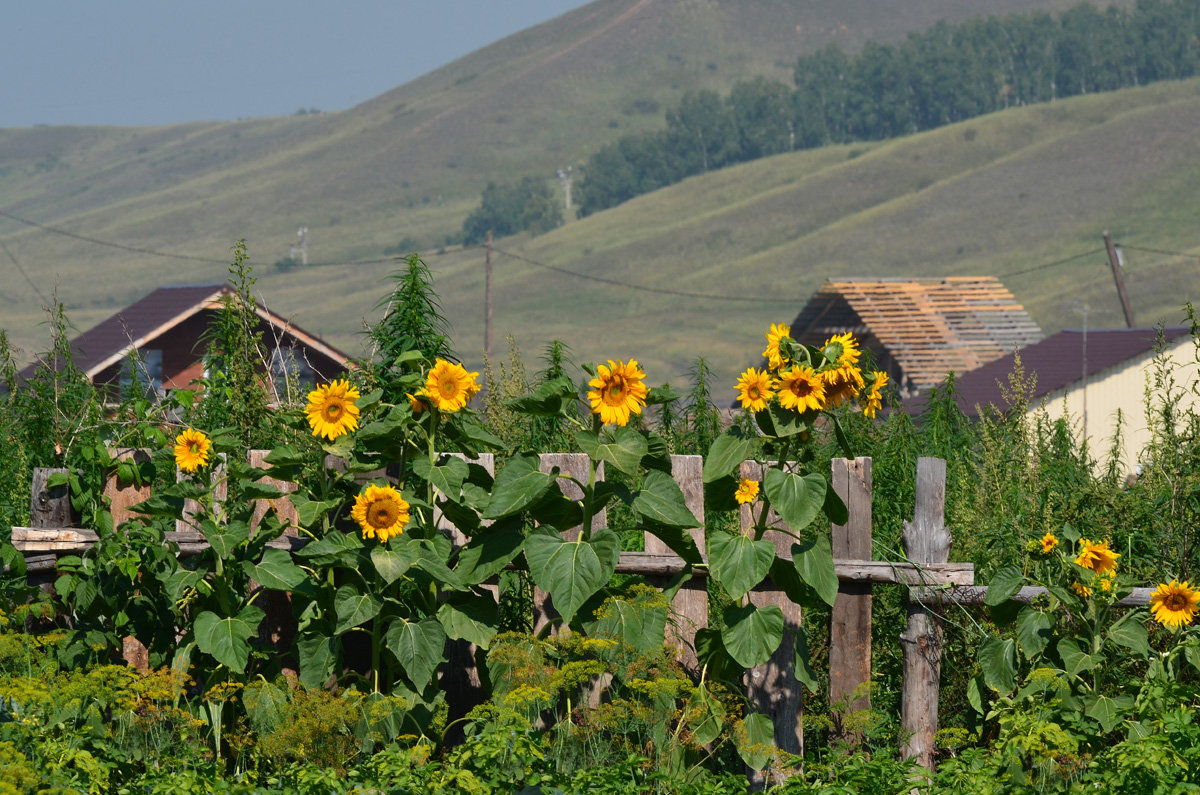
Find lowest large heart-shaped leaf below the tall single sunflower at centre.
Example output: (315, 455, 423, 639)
(526, 527, 620, 623)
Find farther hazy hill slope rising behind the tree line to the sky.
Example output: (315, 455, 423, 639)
(0, 0, 1137, 374)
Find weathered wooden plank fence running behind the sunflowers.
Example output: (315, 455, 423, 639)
(12, 450, 998, 767)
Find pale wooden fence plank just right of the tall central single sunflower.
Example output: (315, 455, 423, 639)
(643, 455, 708, 673)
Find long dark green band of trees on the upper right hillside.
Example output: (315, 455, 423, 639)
(577, 0, 1200, 215)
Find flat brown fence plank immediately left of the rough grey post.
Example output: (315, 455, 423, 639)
(829, 458, 872, 743)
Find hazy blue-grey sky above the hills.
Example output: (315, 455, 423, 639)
(0, 0, 587, 127)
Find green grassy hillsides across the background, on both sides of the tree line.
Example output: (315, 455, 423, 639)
(0, 0, 1171, 393)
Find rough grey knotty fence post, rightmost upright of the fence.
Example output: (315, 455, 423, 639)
(900, 458, 950, 770)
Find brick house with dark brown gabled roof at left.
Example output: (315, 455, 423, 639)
(22, 285, 350, 398)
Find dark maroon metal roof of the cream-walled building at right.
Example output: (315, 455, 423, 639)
(926, 325, 1190, 417)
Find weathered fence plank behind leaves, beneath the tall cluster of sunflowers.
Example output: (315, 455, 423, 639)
(739, 461, 804, 773)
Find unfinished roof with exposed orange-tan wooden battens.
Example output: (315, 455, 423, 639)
(791, 276, 1042, 391)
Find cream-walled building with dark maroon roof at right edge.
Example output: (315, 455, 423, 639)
(910, 325, 1198, 472)
